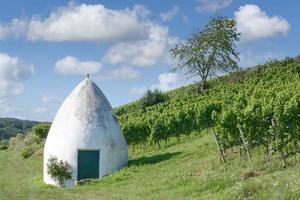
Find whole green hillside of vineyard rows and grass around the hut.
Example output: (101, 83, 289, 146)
(0, 57, 300, 200)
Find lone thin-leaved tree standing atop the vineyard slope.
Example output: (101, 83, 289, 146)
(170, 15, 240, 94)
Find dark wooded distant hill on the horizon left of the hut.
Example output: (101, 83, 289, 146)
(0, 118, 41, 140)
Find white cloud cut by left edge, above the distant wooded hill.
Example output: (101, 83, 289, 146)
(0, 53, 34, 113)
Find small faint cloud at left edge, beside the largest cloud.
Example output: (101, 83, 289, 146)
(0, 19, 28, 40)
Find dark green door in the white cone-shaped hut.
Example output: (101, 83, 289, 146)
(78, 150, 100, 180)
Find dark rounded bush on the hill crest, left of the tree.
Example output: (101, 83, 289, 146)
(141, 88, 167, 108)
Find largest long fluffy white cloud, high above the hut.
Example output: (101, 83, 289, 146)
(27, 2, 149, 42)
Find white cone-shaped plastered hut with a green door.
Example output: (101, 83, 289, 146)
(44, 77, 128, 187)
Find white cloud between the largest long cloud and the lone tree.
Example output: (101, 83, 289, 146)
(103, 23, 177, 67)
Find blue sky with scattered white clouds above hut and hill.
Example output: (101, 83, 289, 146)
(0, 0, 300, 121)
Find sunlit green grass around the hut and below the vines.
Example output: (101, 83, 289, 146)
(0, 134, 300, 200)
